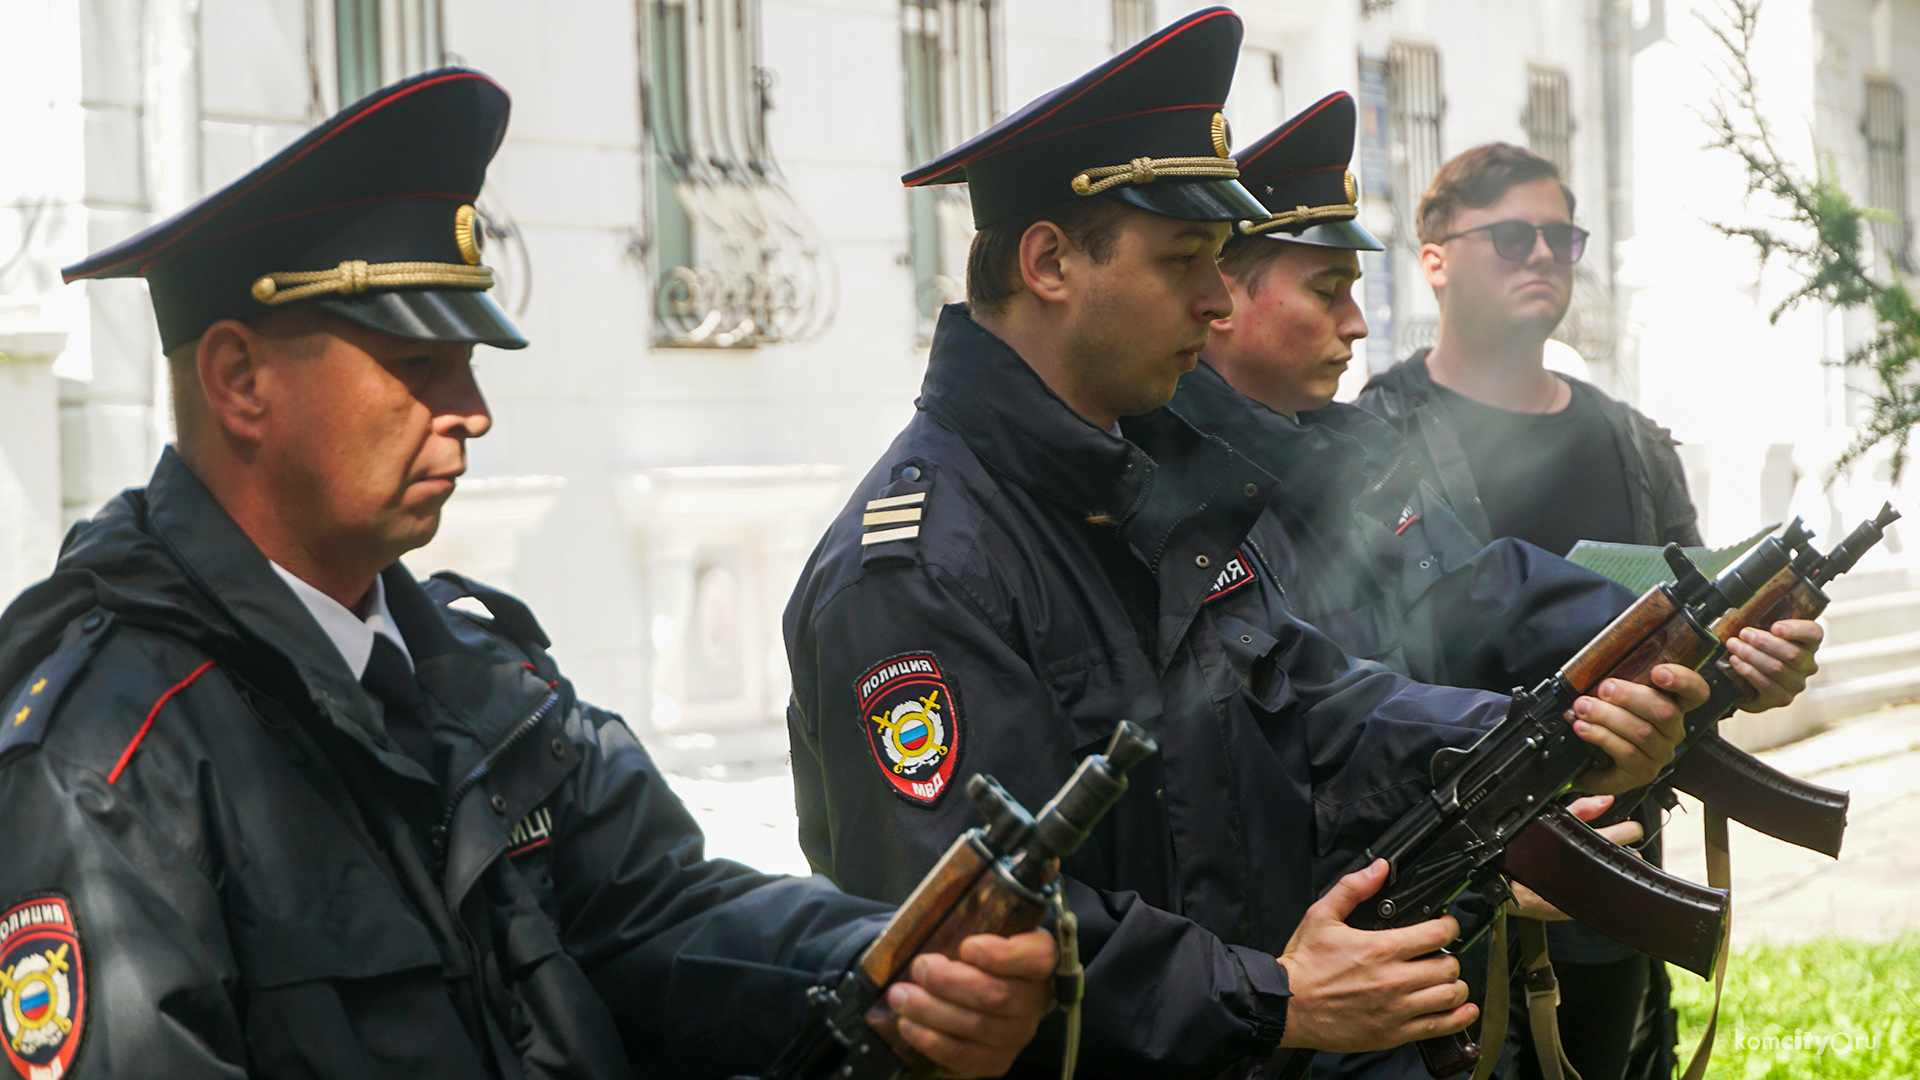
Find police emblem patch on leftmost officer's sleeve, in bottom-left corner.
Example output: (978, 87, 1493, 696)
(0, 896, 86, 1080)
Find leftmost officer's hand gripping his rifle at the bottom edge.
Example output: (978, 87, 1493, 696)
(887, 930, 1054, 1076)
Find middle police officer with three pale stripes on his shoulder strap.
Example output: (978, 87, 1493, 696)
(787, 8, 1705, 1076)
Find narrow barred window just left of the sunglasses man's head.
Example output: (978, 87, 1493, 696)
(1386, 42, 1446, 356)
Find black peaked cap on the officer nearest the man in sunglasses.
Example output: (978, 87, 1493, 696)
(1235, 90, 1384, 252)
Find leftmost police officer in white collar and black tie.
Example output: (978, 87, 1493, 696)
(0, 69, 1052, 1080)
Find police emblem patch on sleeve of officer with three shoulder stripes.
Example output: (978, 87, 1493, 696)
(854, 653, 960, 807)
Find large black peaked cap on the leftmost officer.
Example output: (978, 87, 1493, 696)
(61, 67, 526, 350)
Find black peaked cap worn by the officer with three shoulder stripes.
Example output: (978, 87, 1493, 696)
(900, 8, 1265, 229)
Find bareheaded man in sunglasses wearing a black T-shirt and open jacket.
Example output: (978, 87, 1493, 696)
(1359, 142, 1820, 1080)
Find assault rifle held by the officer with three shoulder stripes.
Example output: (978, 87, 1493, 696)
(1348, 526, 1795, 1076)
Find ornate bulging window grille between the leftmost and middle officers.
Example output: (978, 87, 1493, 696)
(636, 0, 835, 348)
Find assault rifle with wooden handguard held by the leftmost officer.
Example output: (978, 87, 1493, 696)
(766, 721, 1160, 1080)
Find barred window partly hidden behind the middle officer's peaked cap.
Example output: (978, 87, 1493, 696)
(900, 0, 996, 340)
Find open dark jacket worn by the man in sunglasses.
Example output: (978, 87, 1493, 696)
(1356, 350, 1701, 546)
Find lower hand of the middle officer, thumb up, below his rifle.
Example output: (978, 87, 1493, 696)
(1279, 859, 1480, 1051)
